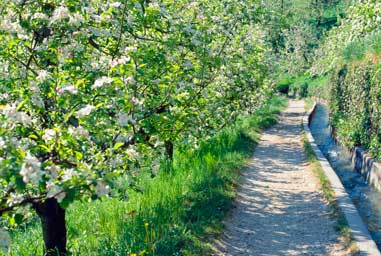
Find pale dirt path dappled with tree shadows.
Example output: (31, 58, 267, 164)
(214, 101, 347, 256)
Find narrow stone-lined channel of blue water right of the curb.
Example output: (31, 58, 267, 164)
(310, 103, 381, 249)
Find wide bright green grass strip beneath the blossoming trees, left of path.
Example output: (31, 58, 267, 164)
(5, 98, 287, 256)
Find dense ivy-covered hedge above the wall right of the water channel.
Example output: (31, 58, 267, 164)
(329, 63, 381, 158)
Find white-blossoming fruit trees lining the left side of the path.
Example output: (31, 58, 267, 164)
(0, 0, 270, 255)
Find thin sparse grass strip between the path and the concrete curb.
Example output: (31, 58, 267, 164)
(303, 136, 358, 255)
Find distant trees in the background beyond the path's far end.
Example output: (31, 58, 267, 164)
(264, 0, 346, 76)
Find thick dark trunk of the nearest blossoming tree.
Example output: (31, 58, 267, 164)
(35, 198, 67, 256)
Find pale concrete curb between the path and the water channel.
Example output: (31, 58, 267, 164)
(303, 102, 381, 256)
